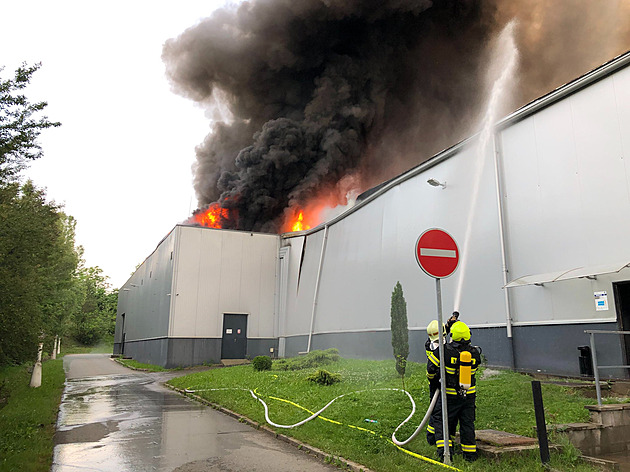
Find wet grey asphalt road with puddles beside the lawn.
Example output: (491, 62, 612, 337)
(52, 354, 339, 472)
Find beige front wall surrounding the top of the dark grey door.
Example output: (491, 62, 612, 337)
(171, 226, 279, 337)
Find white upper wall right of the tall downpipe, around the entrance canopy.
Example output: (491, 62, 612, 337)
(501, 65, 630, 323)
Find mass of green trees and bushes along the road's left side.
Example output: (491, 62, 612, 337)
(0, 64, 118, 366)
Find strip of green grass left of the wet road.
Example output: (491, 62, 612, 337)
(0, 359, 65, 472)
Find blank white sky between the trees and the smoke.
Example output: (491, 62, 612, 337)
(0, 0, 230, 288)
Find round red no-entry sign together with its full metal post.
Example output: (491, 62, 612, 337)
(416, 228, 459, 465)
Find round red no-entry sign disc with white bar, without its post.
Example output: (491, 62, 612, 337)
(416, 228, 459, 279)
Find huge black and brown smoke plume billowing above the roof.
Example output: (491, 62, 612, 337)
(163, 0, 627, 232)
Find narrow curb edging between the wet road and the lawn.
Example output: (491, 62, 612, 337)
(163, 383, 373, 472)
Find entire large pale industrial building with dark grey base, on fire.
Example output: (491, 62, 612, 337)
(114, 53, 630, 377)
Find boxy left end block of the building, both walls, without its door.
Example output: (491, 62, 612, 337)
(115, 226, 279, 367)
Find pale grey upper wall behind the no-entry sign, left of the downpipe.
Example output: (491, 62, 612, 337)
(287, 136, 505, 340)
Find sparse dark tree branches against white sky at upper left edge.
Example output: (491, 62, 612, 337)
(0, 63, 61, 182)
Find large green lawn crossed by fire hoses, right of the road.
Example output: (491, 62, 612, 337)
(169, 359, 595, 472)
